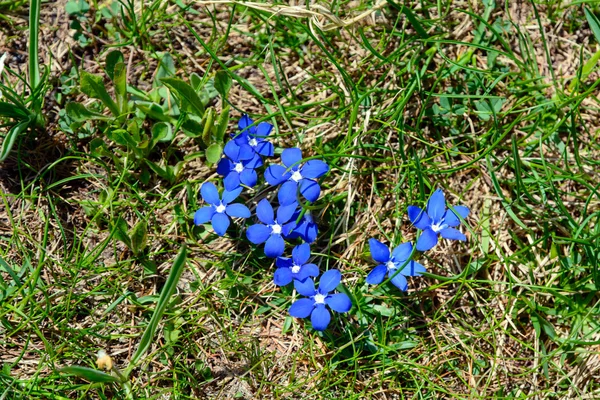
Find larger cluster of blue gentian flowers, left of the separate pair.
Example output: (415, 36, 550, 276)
(194, 115, 352, 331)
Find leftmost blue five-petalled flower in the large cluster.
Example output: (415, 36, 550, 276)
(194, 182, 250, 236)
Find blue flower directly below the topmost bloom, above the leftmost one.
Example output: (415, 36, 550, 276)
(217, 140, 263, 190)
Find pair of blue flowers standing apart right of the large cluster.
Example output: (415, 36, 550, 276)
(367, 189, 469, 291)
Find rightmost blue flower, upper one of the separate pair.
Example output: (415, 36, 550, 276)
(408, 189, 469, 251)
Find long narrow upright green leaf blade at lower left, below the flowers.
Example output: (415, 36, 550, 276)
(125, 245, 187, 370)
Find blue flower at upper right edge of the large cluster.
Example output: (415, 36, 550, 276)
(265, 147, 329, 205)
